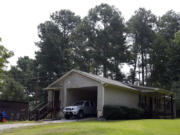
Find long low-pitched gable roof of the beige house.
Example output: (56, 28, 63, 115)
(45, 69, 175, 95)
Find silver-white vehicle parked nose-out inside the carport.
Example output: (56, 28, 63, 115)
(63, 100, 96, 119)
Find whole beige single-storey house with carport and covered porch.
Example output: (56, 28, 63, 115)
(45, 70, 176, 117)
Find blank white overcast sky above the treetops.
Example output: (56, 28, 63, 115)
(0, 0, 180, 65)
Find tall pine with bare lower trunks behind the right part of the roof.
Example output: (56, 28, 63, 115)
(127, 8, 156, 85)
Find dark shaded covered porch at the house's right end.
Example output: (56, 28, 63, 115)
(139, 90, 176, 118)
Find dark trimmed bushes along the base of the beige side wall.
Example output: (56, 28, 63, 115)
(103, 105, 144, 120)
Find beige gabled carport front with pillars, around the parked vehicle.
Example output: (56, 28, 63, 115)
(45, 70, 104, 117)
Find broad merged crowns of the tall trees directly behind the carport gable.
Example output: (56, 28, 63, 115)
(36, 4, 129, 84)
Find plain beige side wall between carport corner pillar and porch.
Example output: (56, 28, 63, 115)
(104, 87, 139, 108)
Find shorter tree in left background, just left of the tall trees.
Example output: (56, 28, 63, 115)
(8, 56, 38, 97)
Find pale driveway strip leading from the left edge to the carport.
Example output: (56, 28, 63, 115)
(0, 118, 95, 133)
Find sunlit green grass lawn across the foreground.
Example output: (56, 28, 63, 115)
(1, 119, 180, 135)
